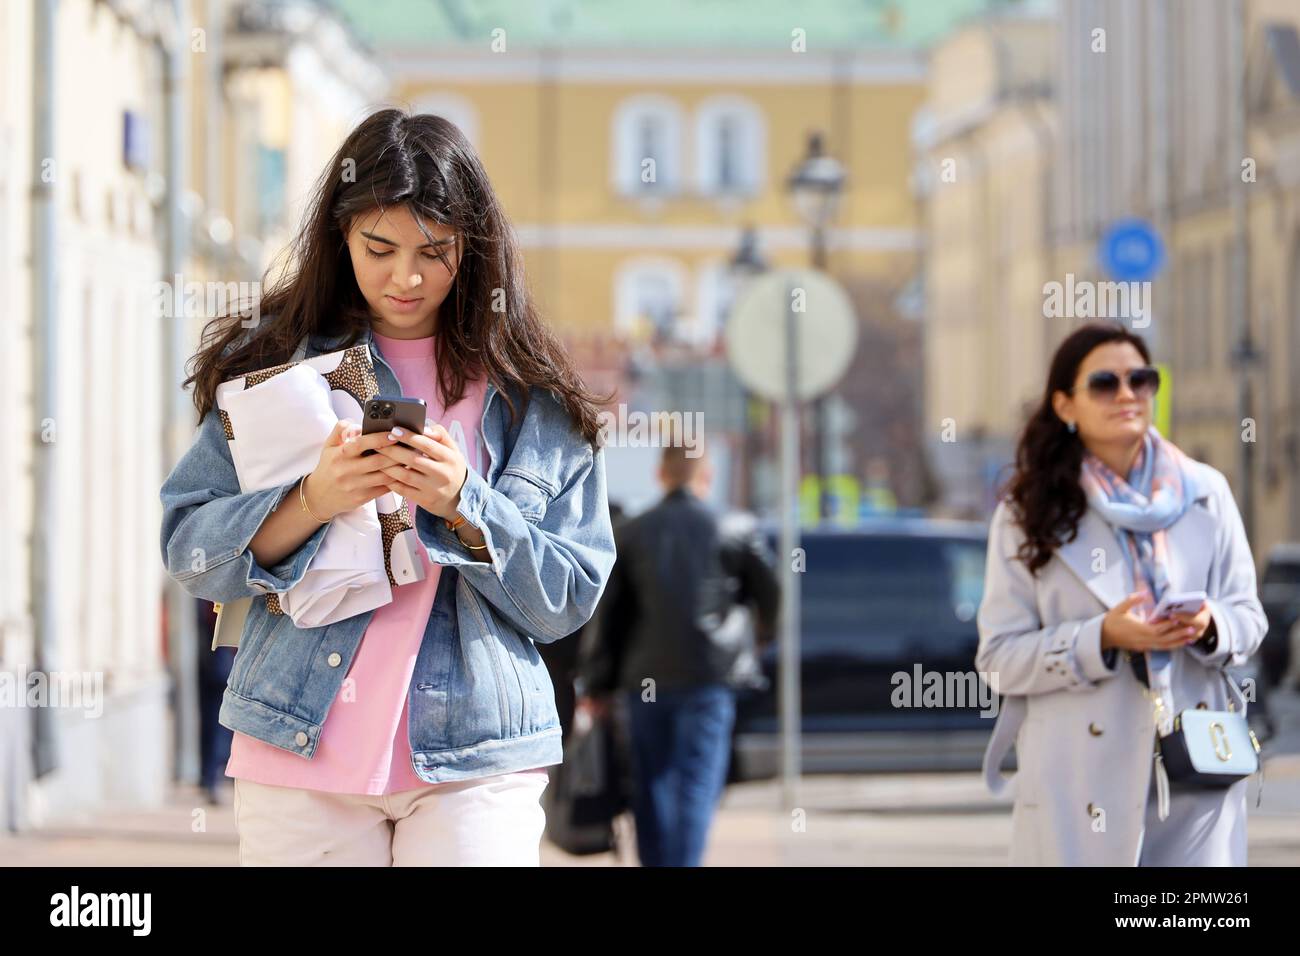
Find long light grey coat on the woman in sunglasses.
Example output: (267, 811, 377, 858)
(976, 463, 1268, 866)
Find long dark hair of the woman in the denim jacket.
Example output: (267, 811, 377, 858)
(185, 109, 612, 447)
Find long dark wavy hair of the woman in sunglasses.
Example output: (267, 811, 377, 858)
(1004, 323, 1151, 574)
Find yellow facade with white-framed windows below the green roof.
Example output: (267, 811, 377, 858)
(387, 48, 923, 346)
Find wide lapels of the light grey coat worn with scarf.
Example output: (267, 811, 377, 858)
(1056, 468, 1217, 607)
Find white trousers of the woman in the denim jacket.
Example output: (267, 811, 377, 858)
(234, 773, 549, 866)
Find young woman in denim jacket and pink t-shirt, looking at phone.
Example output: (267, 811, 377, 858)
(161, 109, 614, 865)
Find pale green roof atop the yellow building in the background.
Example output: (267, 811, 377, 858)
(329, 0, 1017, 52)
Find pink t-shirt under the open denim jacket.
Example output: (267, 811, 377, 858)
(226, 333, 546, 793)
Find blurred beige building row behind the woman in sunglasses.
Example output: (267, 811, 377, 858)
(915, 0, 1300, 564)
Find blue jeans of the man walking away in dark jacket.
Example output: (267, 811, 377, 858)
(625, 684, 736, 866)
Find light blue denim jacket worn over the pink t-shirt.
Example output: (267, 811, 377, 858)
(161, 329, 615, 783)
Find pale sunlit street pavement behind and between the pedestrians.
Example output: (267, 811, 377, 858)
(0, 753, 1300, 866)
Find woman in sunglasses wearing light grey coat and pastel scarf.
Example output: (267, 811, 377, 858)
(976, 324, 1266, 866)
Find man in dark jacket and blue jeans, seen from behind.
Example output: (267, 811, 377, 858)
(579, 445, 780, 866)
